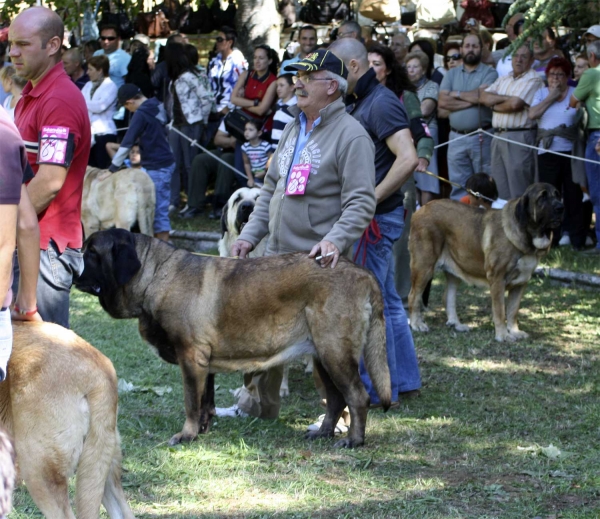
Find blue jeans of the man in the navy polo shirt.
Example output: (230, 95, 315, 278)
(354, 206, 421, 404)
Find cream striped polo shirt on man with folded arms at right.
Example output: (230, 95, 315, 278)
(486, 69, 544, 129)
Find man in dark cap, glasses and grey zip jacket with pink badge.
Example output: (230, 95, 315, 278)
(231, 49, 376, 418)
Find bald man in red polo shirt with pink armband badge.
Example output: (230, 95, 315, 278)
(8, 7, 91, 328)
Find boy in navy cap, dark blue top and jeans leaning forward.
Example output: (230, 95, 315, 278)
(108, 83, 175, 241)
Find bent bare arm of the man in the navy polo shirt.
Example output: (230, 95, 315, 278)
(375, 128, 418, 203)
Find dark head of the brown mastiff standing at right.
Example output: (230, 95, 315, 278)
(515, 182, 565, 249)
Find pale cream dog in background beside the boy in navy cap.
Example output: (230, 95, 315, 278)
(81, 166, 156, 236)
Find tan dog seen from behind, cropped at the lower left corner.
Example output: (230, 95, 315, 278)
(0, 322, 133, 519)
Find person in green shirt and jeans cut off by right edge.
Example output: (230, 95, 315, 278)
(570, 39, 600, 254)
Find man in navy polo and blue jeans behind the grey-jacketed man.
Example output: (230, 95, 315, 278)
(329, 38, 421, 412)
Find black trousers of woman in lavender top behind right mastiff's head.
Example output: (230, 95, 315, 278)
(537, 153, 587, 248)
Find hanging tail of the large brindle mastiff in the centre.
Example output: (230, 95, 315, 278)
(364, 275, 392, 411)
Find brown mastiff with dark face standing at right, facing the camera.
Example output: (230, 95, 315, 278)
(408, 183, 564, 342)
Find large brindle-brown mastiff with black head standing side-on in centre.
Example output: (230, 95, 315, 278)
(76, 229, 391, 447)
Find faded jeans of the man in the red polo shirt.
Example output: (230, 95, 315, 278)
(13, 241, 83, 328)
